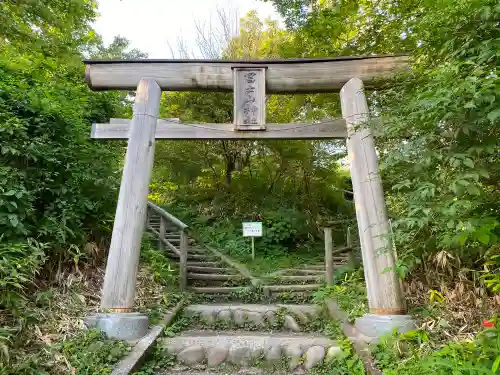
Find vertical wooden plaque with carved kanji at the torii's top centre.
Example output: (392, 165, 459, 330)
(233, 67, 266, 130)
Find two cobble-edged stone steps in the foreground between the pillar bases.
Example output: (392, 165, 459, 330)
(161, 304, 342, 374)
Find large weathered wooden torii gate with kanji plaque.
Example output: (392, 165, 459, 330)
(85, 56, 414, 337)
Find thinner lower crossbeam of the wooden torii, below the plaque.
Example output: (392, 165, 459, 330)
(91, 119, 347, 140)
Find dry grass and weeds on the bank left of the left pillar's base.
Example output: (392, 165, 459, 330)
(0, 268, 130, 375)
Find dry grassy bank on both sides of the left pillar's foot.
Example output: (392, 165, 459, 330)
(0, 238, 180, 375)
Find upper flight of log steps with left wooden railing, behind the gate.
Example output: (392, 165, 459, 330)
(146, 202, 352, 301)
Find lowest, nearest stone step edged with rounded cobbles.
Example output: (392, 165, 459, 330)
(162, 331, 341, 370)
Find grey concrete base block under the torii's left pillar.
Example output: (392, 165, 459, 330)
(84, 312, 149, 341)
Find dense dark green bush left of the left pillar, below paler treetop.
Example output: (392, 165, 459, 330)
(0, 47, 121, 255)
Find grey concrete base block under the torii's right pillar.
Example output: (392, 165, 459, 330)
(354, 314, 417, 342)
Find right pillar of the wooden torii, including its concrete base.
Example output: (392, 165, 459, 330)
(340, 78, 415, 341)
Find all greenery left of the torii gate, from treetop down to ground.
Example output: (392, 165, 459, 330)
(0, 0, 143, 375)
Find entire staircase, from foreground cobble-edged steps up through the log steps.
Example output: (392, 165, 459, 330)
(142, 204, 351, 375)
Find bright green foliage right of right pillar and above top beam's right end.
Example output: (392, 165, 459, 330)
(262, 0, 500, 277)
